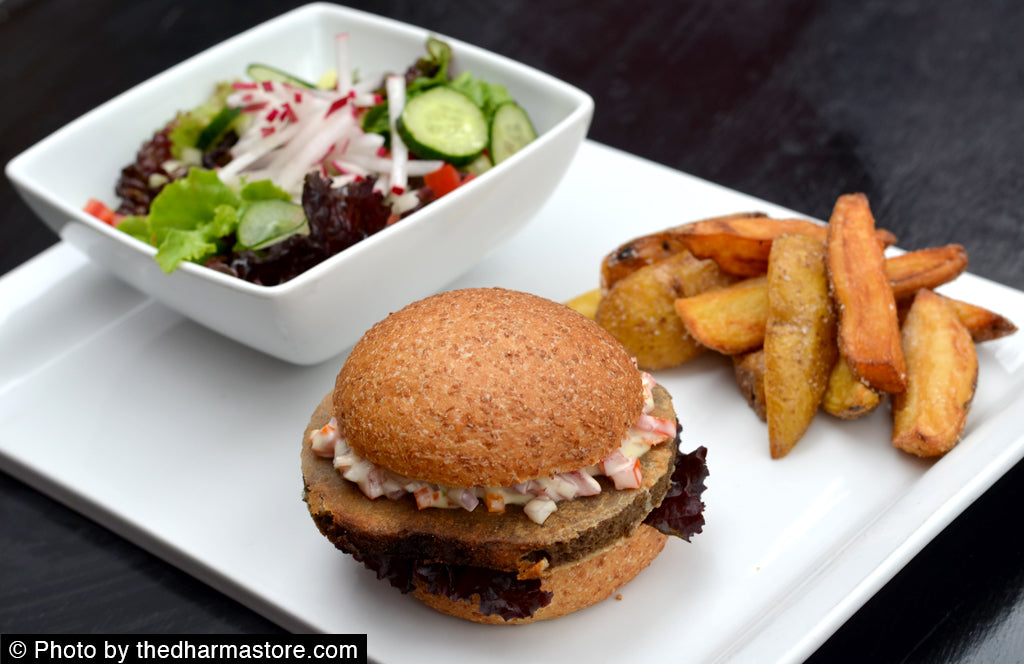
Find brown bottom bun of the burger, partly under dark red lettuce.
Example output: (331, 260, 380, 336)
(413, 524, 669, 625)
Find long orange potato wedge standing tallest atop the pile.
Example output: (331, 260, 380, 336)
(827, 194, 906, 393)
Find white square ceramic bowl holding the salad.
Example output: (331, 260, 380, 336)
(6, 3, 594, 365)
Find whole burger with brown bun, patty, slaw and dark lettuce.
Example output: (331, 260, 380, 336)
(301, 288, 708, 624)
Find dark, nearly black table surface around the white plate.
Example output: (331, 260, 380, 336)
(0, 0, 1024, 662)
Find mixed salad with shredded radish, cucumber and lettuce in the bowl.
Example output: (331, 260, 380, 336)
(85, 33, 537, 286)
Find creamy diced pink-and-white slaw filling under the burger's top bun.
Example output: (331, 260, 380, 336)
(309, 372, 676, 524)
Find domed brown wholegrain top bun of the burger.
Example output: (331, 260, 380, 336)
(333, 288, 643, 487)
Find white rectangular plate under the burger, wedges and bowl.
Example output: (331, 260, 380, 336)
(0, 142, 1024, 663)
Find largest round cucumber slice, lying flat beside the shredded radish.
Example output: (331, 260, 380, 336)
(397, 86, 487, 166)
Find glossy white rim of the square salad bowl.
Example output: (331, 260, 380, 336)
(4, 2, 594, 299)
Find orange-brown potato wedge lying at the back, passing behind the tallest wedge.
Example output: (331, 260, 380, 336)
(673, 213, 896, 277)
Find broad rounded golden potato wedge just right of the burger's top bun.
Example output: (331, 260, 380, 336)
(594, 250, 734, 371)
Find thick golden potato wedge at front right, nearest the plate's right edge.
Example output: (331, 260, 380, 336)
(892, 290, 978, 457)
